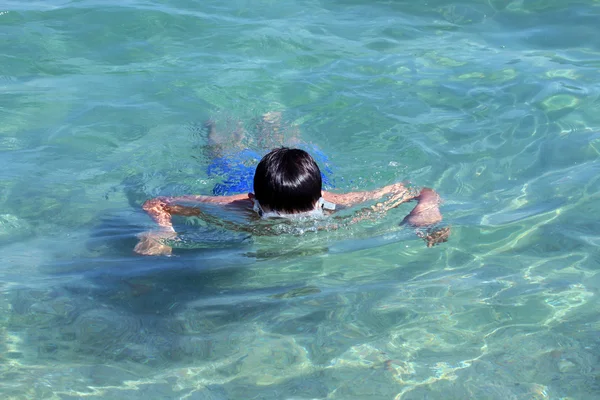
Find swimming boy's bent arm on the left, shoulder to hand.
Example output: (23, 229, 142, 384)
(134, 194, 252, 255)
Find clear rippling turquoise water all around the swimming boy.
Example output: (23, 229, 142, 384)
(0, 0, 600, 400)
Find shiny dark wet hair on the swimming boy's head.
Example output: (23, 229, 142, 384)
(254, 147, 322, 213)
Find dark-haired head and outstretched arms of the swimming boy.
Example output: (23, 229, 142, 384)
(134, 147, 449, 255)
